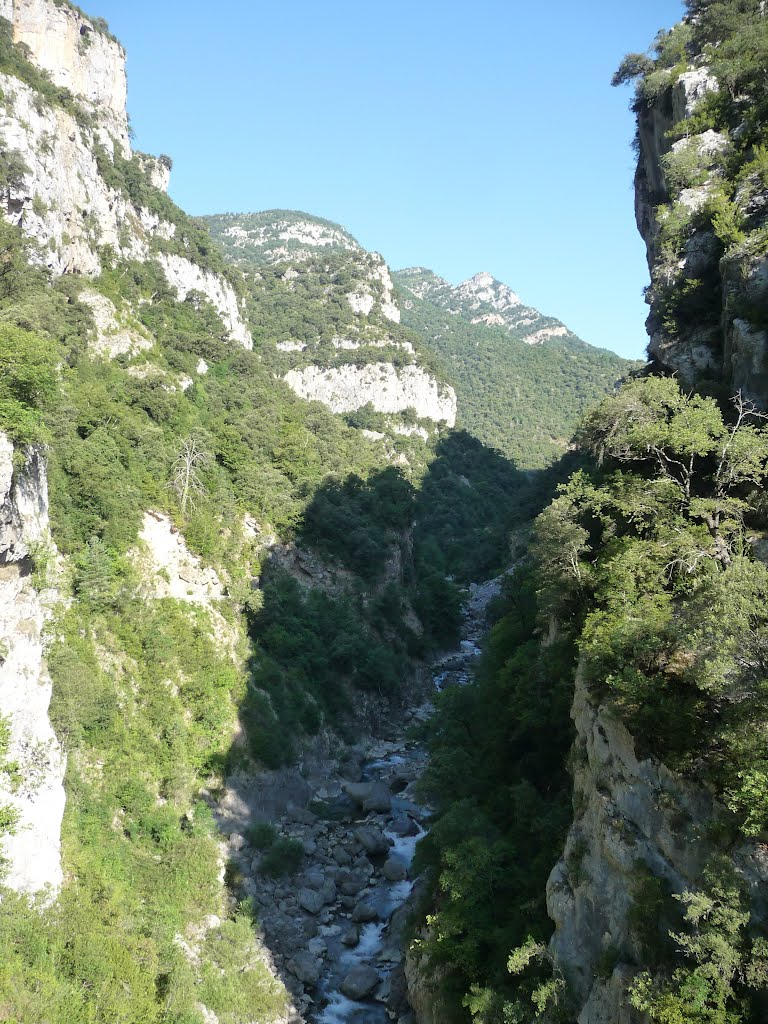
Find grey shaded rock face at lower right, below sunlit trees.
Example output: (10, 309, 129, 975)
(547, 668, 768, 1024)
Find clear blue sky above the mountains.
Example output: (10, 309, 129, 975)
(91, 0, 682, 356)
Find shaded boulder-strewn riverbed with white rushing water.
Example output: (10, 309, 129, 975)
(217, 578, 512, 1024)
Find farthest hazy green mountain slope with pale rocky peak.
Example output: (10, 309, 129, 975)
(394, 267, 634, 468)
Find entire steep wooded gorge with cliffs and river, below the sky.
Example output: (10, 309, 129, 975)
(0, 0, 768, 1024)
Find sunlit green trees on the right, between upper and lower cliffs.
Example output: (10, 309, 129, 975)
(538, 378, 768, 835)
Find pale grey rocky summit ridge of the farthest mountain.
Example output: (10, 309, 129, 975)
(395, 266, 575, 345)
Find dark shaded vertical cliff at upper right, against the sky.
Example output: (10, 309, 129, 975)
(635, 57, 768, 408)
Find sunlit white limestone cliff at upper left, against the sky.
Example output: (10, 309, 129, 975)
(0, 0, 252, 354)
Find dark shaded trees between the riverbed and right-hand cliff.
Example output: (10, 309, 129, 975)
(417, 567, 574, 1021)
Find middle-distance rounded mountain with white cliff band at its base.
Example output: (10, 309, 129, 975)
(206, 210, 456, 437)
